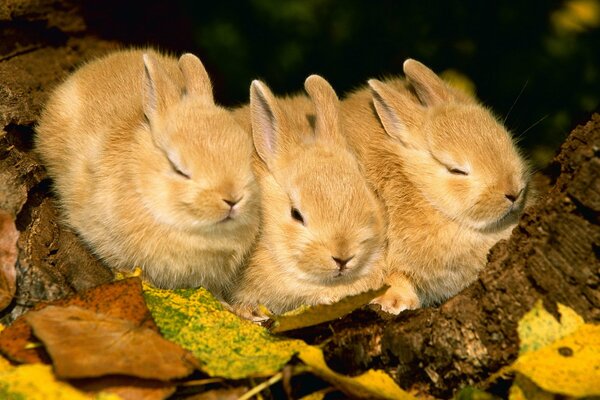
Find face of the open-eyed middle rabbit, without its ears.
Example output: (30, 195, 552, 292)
(267, 146, 383, 285)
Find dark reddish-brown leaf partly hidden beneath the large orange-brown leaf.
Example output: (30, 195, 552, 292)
(0, 278, 158, 364)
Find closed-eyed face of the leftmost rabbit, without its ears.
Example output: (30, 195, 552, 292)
(147, 104, 258, 234)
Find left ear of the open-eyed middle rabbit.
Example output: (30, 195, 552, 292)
(250, 80, 284, 167)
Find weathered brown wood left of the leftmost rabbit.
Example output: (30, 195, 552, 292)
(0, 0, 116, 323)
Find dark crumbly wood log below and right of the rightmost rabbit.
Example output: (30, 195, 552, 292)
(314, 115, 600, 397)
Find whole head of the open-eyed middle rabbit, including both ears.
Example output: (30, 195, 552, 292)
(250, 75, 384, 285)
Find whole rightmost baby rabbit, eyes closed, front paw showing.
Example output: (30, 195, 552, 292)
(342, 60, 529, 313)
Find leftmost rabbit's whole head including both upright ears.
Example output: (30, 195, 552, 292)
(139, 54, 259, 235)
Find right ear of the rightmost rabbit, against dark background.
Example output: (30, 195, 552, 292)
(403, 58, 473, 107)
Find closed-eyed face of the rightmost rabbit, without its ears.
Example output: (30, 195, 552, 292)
(403, 105, 528, 230)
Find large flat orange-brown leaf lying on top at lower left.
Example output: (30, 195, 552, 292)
(25, 306, 197, 381)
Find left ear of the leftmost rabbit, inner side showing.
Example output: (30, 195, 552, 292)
(142, 53, 179, 125)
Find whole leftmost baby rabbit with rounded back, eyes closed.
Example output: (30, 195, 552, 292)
(36, 50, 260, 298)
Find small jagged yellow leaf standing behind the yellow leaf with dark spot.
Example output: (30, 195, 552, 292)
(517, 300, 584, 354)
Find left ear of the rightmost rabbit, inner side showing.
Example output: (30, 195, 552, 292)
(368, 79, 425, 147)
